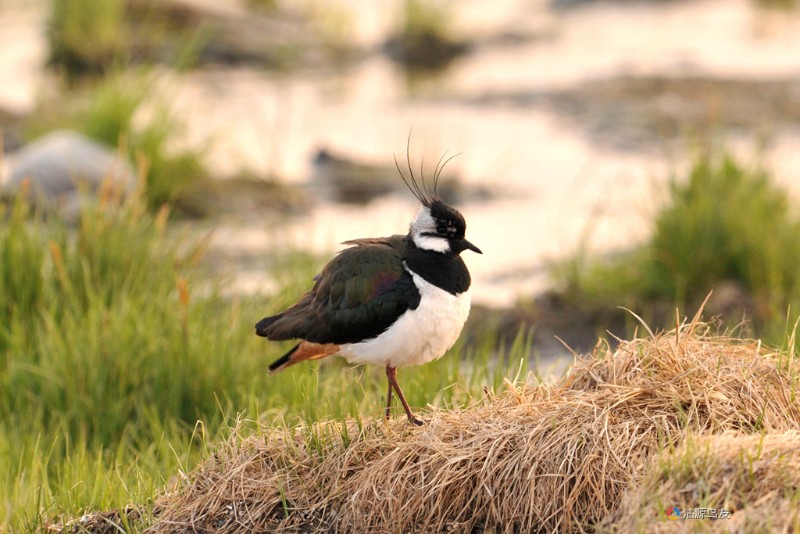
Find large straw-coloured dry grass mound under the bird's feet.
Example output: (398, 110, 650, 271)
(147, 322, 800, 533)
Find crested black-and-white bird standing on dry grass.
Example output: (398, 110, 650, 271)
(256, 154, 483, 426)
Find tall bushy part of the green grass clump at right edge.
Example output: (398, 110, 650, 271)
(650, 154, 800, 313)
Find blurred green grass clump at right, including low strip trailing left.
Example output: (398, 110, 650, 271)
(556, 152, 800, 334)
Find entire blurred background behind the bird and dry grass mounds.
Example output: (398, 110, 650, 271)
(0, 0, 800, 530)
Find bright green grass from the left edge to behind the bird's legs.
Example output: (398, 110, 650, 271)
(0, 187, 529, 531)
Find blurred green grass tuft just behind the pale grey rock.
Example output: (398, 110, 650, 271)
(28, 70, 206, 211)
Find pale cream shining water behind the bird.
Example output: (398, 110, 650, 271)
(0, 0, 800, 305)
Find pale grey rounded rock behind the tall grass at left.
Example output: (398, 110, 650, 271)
(2, 130, 136, 221)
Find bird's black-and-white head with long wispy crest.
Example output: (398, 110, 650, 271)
(395, 149, 483, 256)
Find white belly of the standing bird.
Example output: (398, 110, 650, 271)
(338, 271, 470, 367)
